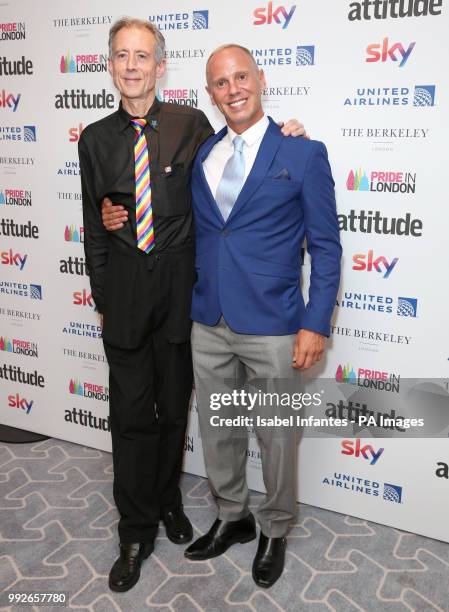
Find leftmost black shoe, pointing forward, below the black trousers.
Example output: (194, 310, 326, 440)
(109, 542, 154, 592)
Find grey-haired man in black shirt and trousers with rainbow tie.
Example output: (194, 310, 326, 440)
(79, 18, 213, 591)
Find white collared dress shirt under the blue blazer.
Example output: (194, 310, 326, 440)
(203, 115, 269, 198)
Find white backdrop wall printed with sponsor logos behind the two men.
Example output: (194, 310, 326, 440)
(0, 0, 449, 541)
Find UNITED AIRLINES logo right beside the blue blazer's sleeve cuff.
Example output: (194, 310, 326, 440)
(335, 291, 418, 318)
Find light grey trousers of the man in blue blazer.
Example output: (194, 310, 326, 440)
(192, 318, 299, 537)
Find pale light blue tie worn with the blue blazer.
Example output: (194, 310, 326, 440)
(215, 136, 245, 221)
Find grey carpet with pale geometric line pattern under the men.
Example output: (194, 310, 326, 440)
(0, 439, 449, 612)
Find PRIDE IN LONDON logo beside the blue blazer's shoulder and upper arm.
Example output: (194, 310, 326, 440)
(346, 168, 416, 193)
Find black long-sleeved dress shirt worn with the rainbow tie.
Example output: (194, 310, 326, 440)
(78, 100, 213, 312)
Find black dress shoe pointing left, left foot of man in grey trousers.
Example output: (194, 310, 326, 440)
(184, 514, 256, 561)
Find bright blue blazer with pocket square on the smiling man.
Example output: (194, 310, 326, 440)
(192, 118, 341, 336)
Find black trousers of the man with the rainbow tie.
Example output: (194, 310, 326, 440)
(104, 244, 194, 543)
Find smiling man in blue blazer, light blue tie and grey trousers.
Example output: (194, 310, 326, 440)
(185, 45, 341, 587)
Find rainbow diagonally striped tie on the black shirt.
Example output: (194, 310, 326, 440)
(131, 119, 154, 253)
